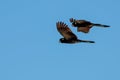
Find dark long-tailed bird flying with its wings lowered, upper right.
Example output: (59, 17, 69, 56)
(69, 18, 110, 33)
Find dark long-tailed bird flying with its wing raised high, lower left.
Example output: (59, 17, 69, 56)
(56, 22, 95, 44)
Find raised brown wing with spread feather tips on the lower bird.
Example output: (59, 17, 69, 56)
(56, 22, 77, 40)
